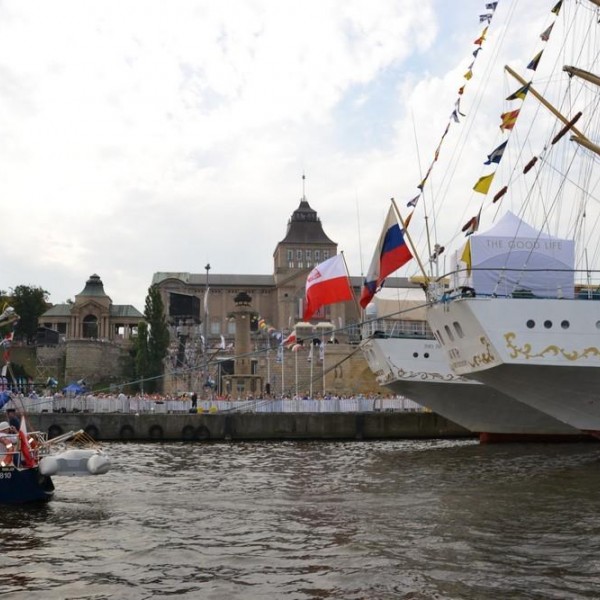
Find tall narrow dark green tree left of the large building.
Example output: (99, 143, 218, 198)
(135, 285, 170, 392)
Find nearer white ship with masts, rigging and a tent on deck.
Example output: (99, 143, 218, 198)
(427, 0, 600, 435)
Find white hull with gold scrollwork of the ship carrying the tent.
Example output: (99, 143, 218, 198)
(427, 298, 600, 435)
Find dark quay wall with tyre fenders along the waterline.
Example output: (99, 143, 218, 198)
(28, 412, 474, 441)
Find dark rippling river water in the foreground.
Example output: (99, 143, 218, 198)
(0, 440, 600, 600)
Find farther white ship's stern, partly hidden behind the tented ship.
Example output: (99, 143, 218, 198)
(362, 290, 583, 442)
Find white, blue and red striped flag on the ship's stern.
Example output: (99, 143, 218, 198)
(360, 206, 412, 308)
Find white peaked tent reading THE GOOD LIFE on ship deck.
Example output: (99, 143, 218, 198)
(459, 212, 575, 298)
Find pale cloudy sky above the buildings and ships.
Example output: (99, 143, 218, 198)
(0, 0, 553, 310)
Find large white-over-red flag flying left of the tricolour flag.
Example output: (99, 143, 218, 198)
(303, 254, 354, 321)
